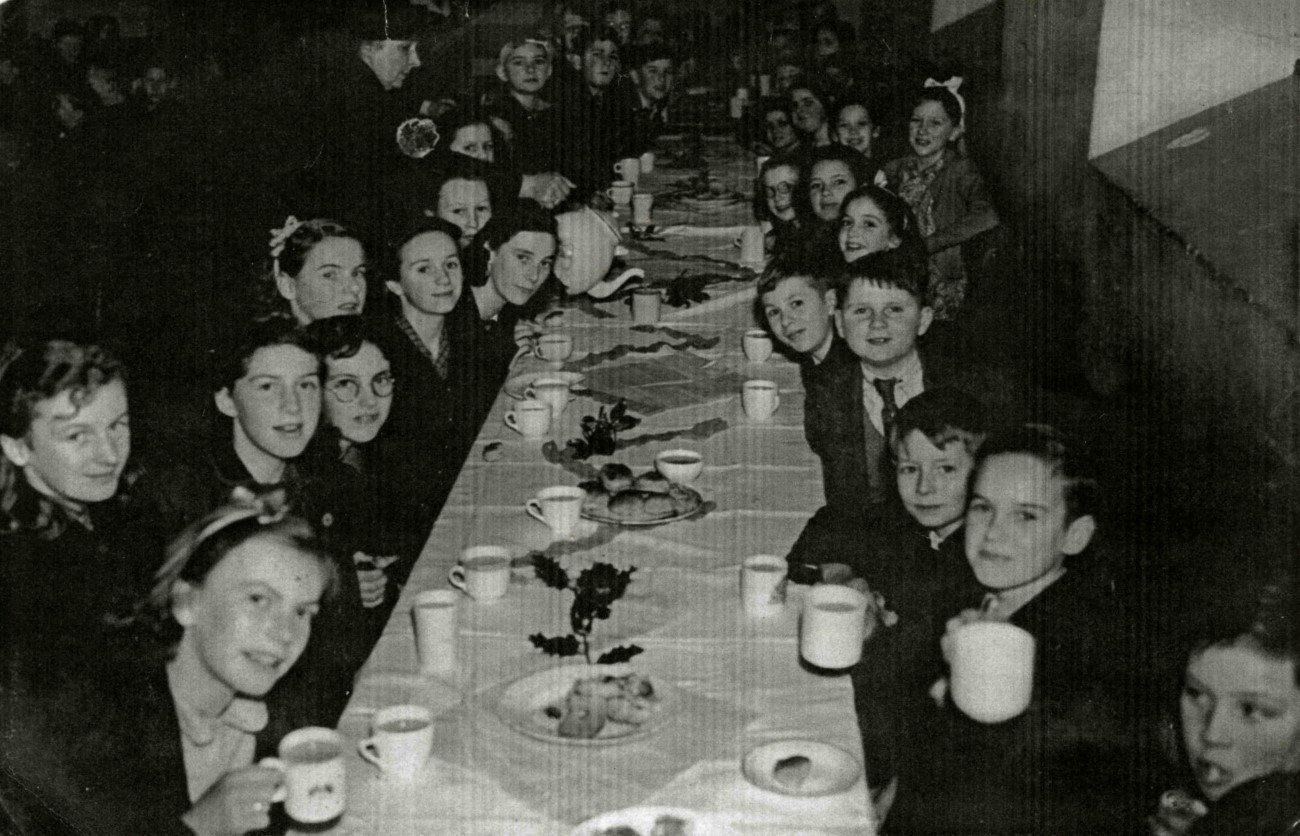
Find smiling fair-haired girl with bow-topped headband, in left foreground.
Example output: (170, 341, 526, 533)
(0, 494, 334, 836)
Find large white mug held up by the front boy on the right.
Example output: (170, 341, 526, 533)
(949, 621, 1035, 723)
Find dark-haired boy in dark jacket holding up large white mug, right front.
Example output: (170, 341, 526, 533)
(884, 425, 1141, 833)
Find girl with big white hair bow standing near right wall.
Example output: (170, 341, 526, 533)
(881, 79, 998, 320)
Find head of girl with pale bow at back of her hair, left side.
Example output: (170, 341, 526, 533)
(267, 217, 365, 325)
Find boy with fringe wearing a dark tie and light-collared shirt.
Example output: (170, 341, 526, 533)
(787, 251, 941, 584)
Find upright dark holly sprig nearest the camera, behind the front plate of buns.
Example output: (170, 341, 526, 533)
(528, 554, 642, 664)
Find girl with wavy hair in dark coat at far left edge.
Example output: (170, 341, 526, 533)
(0, 339, 147, 681)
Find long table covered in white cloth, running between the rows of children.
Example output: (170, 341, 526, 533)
(301, 137, 874, 836)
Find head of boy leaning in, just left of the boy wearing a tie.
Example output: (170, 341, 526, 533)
(758, 254, 854, 389)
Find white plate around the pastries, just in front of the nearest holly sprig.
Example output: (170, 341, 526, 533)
(497, 664, 677, 746)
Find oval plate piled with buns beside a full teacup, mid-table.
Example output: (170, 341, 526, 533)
(579, 463, 705, 527)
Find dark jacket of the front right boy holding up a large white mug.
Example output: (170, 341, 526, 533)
(884, 555, 1149, 835)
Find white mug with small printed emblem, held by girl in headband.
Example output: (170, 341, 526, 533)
(260, 725, 347, 824)
